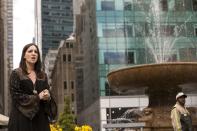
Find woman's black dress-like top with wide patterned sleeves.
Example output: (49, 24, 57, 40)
(8, 68, 50, 131)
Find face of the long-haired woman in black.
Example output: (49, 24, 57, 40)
(24, 45, 38, 64)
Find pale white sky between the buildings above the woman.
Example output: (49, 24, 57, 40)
(13, 0, 34, 68)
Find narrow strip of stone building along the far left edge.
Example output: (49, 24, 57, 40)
(0, 0, 8, 114)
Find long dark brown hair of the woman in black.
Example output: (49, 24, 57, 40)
(19, 43, 44, 78)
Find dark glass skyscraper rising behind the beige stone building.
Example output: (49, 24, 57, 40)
(35, 0, 73, 58)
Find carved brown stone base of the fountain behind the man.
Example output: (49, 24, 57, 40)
(138, 106, 197, 131)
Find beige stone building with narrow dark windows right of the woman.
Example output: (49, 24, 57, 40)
(51, 33, 83, 115)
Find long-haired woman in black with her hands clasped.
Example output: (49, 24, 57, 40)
(8, 43, 56, 131)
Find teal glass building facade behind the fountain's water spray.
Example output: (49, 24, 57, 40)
(96, 0, 197, 96)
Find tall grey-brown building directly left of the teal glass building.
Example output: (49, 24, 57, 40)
(76, 0, 100, 131)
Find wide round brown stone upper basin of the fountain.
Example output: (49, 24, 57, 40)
(107, 62, 197, 93)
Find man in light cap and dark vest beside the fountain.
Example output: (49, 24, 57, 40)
(171, 92, 192, 131)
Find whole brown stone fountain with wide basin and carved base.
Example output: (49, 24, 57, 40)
(107, 62, 197, 131)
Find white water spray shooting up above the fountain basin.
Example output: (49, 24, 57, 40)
(134, 0, 193, 63)
